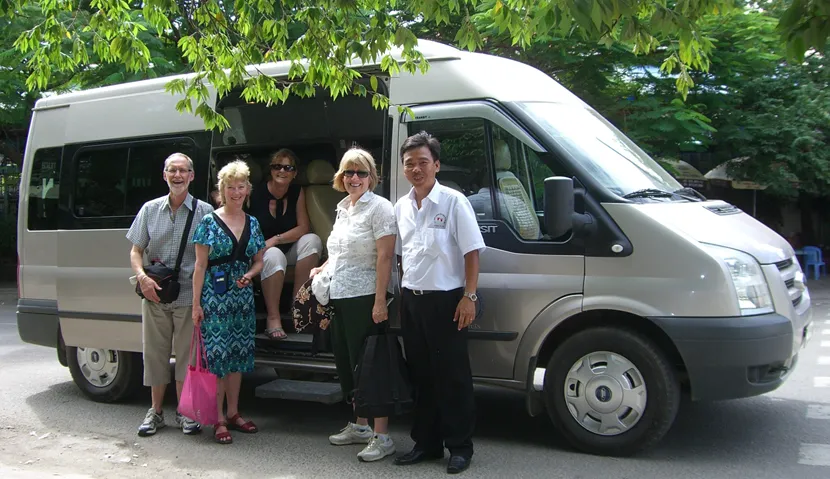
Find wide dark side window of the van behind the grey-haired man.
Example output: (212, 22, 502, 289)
(73, 139, 196, 218)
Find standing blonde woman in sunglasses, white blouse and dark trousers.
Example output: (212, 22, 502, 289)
(311, 148, 397, 461)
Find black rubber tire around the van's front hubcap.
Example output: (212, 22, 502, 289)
(543, 327, 681, 456)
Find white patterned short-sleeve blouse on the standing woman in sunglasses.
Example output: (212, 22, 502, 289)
(326, 191, 397, 299)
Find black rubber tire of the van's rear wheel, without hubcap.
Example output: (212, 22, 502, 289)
(66, 346, 144, 403)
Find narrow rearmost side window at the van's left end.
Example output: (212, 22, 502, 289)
(28, 147, 62, 231)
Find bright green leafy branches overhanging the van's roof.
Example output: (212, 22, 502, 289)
(0, 0, 732, 129)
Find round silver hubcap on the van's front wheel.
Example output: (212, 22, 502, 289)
(565, 351, 647, 436)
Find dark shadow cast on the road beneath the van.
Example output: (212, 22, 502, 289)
(19, 370, 823, 464)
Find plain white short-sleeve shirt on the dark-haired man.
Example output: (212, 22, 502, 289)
(395, 180, 485, 291)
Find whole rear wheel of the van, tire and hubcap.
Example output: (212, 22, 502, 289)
(66, 347, 143, 403)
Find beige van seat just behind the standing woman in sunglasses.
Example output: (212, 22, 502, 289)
(305, 160, 346, 251)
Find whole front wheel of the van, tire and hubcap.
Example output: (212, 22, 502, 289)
(544, 327, 680, 456)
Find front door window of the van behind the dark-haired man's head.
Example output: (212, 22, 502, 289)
(409, 118, 494, 220)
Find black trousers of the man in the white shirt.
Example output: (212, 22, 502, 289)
(401, 288, 475, 457)
